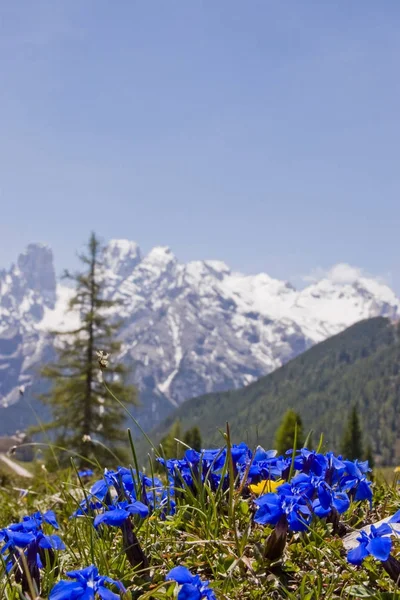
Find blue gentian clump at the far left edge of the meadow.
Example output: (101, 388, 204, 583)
(0, 510, 65, 591)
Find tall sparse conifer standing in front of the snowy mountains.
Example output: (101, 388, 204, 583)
(41, 233, 136, 461)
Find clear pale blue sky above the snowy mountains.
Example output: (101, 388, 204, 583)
(0, 0, 400, 293)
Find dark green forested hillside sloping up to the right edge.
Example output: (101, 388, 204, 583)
(141, 317, 400, 464)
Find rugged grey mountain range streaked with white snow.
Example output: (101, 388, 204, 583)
(0, 240, 400, 434)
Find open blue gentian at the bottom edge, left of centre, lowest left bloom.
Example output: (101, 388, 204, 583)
(49, 565, 126, 600)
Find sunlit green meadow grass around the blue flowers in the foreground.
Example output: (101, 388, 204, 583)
(0, 438, 400, 600)
